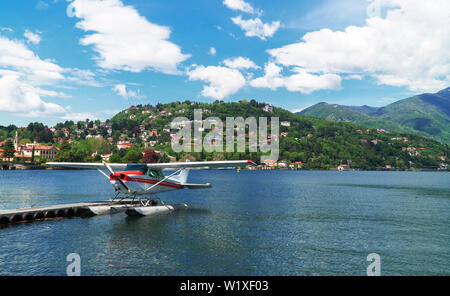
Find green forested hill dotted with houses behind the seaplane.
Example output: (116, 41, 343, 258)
(0, 100, 449, 169)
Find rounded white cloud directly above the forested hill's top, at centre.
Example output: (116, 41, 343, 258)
(187, 66, 245, 100)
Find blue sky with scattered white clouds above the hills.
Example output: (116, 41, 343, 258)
(0, 0, 450, 126)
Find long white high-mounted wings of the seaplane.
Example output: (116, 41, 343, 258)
(47, 160, 255, 170)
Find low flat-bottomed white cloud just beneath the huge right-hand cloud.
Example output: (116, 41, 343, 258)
(250, 62, 341, 94)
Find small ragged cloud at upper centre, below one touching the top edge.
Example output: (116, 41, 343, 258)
(231, 15, 280, 40)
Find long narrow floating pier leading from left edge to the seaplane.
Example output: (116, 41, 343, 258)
(0, 199, 139, 225)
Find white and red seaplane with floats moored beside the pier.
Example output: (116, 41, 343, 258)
(47, 160, 255, 216)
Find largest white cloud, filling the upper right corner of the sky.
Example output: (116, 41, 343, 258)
(268, 0, 450, 92)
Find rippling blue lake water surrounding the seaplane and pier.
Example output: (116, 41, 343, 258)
(0, 170, 450, 275)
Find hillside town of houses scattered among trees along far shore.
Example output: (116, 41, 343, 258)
(0, 100, 448, 171)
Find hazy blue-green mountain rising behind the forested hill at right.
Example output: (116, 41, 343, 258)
(299, 87, 450, 144)
